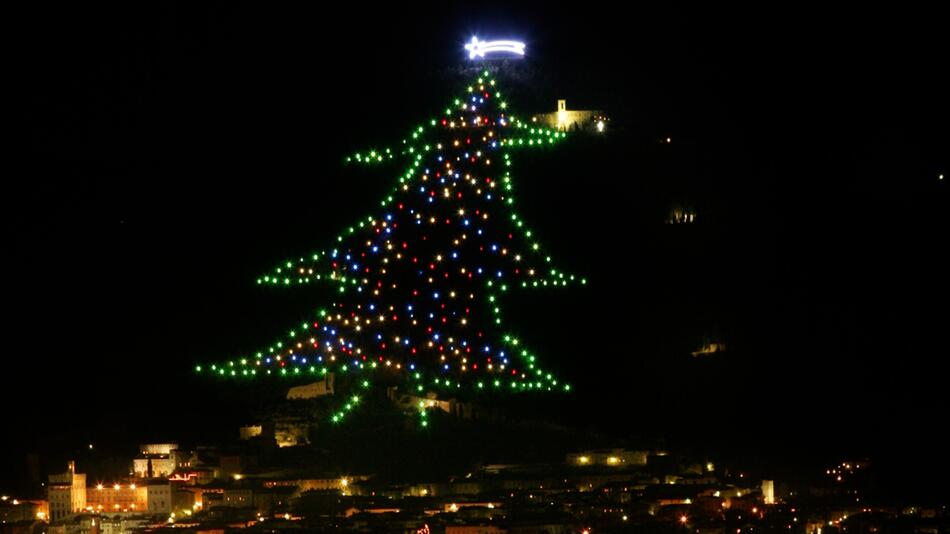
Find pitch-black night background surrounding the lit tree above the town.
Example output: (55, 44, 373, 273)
(0, 2, 950, 490)
